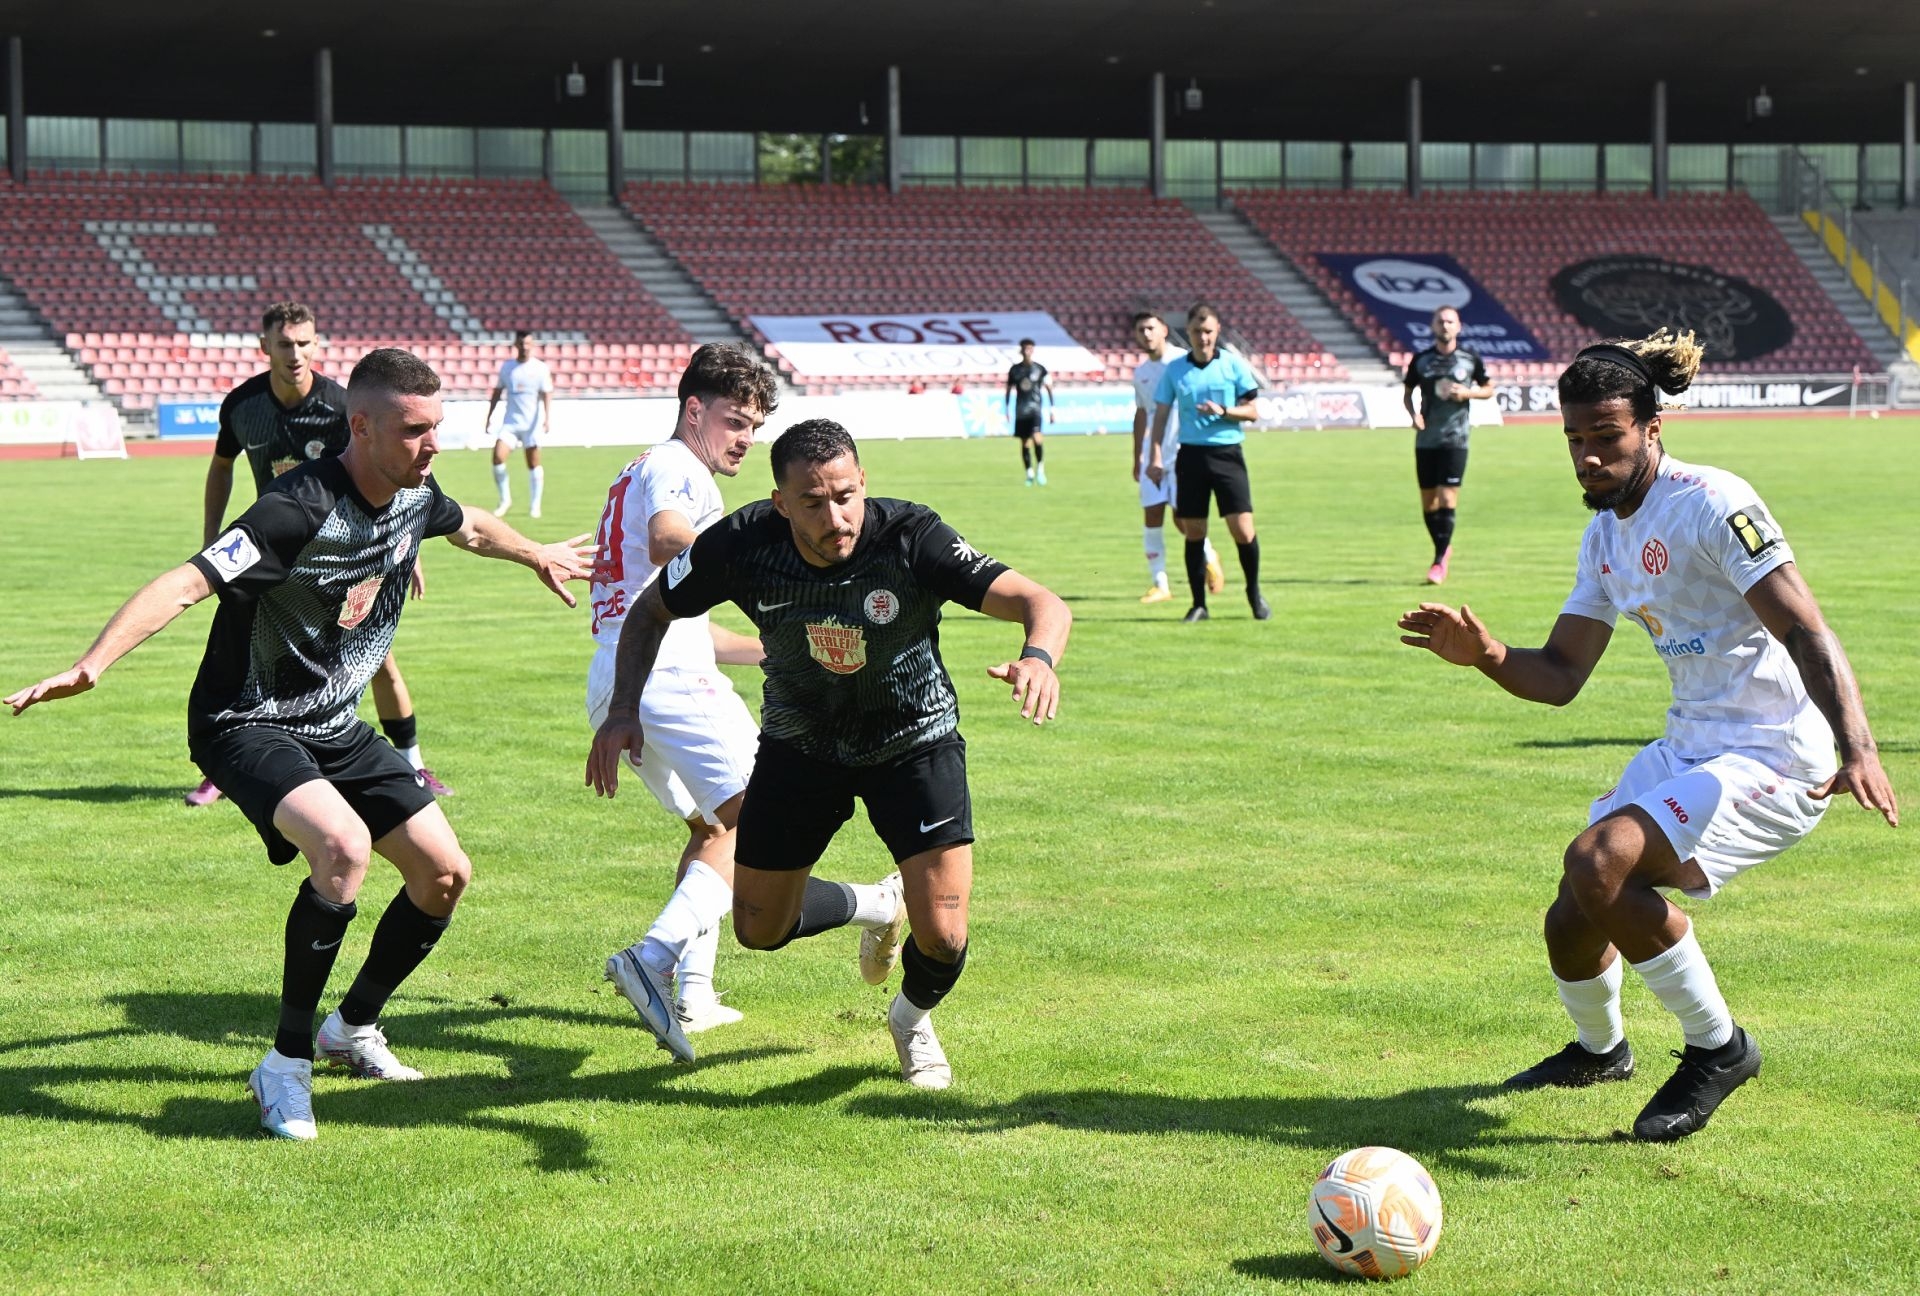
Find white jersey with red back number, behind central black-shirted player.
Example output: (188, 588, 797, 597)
(593, 438, 726, 672)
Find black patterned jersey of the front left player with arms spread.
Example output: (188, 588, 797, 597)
(186, 457, 465, 739)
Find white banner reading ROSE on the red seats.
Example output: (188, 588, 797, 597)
(749, 311, 1104, 382)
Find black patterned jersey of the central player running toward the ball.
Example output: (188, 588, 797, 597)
(660, 499, 1006, 766)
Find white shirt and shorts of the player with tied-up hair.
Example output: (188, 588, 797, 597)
(1561, 455, 1836, 899)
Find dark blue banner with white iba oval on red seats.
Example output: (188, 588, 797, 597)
(1313, 252, 1553, 361)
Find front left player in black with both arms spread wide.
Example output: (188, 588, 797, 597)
(4, 348, 593, 1139)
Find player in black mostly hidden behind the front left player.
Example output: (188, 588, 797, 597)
(197, 301, 453, 806)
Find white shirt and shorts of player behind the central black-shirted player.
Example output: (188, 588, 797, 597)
(588, 440, 760, 824)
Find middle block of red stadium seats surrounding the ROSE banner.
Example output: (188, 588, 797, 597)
(624, 184, 1346, 388)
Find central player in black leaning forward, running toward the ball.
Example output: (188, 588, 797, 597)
(588, 419, 1073, 1089)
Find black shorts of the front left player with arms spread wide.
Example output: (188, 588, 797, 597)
(192, 720, 434, 864)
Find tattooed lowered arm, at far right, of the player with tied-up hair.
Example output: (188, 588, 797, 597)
(1747, 563, 1901, 828)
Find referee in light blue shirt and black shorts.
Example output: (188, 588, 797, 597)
(1146, 301, 1273, 620)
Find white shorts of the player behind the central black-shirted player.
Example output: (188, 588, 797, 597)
(588, 647, 760, 824)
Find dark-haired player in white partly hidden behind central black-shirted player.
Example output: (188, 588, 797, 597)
(588, 344, 904, 1062)
